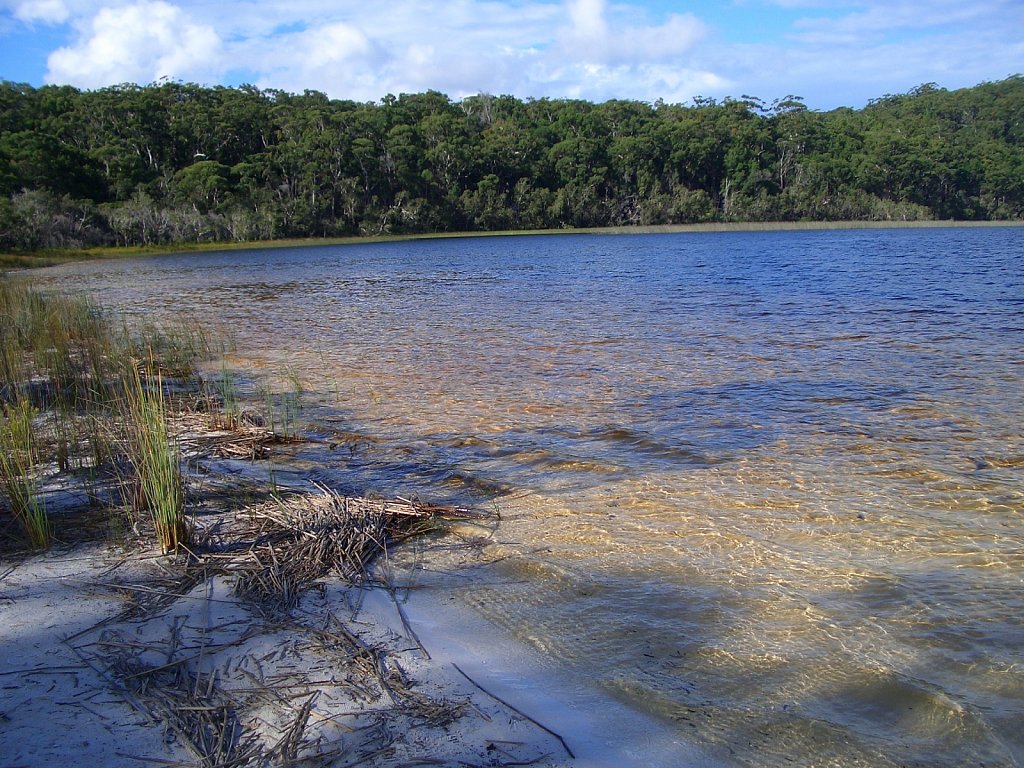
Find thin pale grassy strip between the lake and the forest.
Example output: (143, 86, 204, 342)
(0, 219, 1024, 270)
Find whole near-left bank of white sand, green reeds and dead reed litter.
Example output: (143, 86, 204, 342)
(0, 278, 572, 768)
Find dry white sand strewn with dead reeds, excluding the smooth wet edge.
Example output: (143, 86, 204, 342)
(0, 532, 568, 766)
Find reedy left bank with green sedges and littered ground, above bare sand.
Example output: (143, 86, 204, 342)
(0, 276, 444, 566)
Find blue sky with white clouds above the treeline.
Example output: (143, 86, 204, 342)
(0, 0, 1024, 111)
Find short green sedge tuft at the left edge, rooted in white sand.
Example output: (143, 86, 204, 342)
(0, 398, 52, 549)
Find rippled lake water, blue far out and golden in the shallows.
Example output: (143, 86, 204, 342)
(40, 229, 1024, 766)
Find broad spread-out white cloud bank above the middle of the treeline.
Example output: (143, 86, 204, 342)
(207, 0, 714, 100)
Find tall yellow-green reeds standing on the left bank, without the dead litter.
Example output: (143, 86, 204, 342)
(0, 280, 209, 552)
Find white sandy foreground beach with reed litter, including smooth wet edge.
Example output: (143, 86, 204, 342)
(0, 444, 713, 768)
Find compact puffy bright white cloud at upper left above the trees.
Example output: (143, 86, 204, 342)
(46, 0, 221, 88)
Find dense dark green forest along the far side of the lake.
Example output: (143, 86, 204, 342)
(0, 75, 1024, 251)
